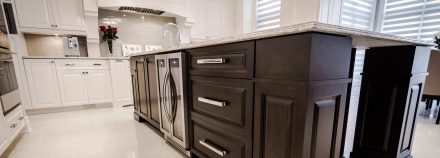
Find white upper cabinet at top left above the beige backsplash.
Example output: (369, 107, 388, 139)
(15, 0, 85, 31)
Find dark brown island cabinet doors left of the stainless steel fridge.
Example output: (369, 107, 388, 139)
(130, 55, 160, 129)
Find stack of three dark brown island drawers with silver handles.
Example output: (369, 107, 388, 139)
(188, 41, 255, 158)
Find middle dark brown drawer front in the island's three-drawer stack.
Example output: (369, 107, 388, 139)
(191, 76, 253, 129)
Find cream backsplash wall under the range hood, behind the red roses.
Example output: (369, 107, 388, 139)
(97, 9, 176, 56)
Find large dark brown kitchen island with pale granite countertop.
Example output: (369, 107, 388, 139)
(130, 22, 430, 158)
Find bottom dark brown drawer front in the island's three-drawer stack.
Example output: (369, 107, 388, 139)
(192, 122, 251, 158)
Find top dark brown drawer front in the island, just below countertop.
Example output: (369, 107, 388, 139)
(188, 41, 255, 78)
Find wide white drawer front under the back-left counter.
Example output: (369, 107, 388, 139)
(55, 59, 110, 69)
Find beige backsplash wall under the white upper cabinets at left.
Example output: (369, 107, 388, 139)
(24, 34, 88, 57)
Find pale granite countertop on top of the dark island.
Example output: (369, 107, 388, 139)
(131, 22, 433, 56)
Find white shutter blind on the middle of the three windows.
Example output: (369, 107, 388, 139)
(341, 0, 376, 30)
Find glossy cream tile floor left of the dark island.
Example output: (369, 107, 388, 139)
(1, 107, 183, 158)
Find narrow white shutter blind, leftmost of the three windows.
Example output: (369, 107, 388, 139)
(256, 0, 281, 30)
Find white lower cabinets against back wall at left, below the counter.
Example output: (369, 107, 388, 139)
(24, 59, 113, 109)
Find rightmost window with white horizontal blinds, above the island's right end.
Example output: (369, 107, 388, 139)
(382, 0, 440, 42)
